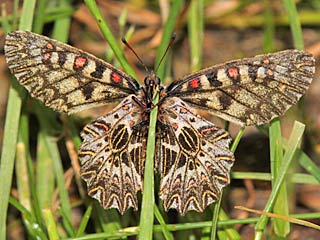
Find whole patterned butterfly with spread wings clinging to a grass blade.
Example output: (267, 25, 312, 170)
(5, 31, 315, 215)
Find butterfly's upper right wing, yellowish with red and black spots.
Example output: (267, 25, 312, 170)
(166, 50, 315, 125)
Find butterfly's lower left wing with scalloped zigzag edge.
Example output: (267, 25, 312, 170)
(79, 95, 147, 214)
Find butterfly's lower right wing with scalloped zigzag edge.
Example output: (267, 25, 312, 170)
(158, 98, 234, 215)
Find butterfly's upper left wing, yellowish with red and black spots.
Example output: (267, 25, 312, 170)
(4, 31, 139, 113)
